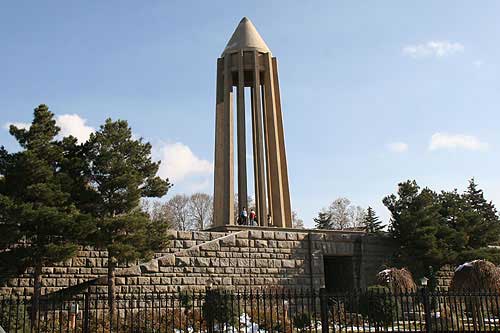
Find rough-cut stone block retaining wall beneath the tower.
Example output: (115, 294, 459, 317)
(0, 228, 392, 294)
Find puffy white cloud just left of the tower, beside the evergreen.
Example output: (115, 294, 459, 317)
(155, 142, 214, 184)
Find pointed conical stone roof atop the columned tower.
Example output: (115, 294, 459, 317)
(222, 17, 271, 56)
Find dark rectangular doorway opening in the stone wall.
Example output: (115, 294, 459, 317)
(323, 256, 355, 291)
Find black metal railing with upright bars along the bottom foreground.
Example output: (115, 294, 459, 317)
(0, 288, 500, 333)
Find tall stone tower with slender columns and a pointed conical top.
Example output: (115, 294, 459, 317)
(214, 17, 292, 227)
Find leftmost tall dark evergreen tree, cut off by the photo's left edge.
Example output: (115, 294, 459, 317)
(0, 104, 92, 316)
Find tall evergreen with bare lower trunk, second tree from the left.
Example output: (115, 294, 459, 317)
(84, 119, 171, 318)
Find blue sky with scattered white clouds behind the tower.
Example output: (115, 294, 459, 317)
(0, 0, 500, 226)
